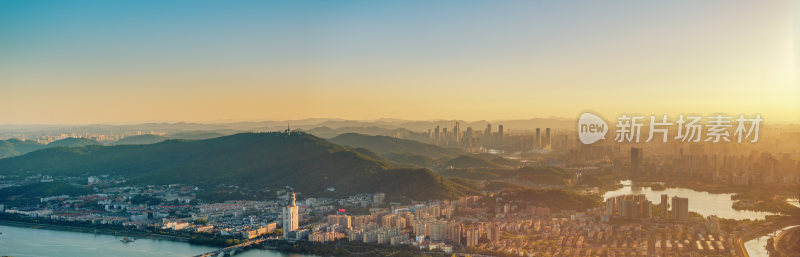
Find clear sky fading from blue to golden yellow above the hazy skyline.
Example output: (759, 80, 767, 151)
(0, 0, 800, 124)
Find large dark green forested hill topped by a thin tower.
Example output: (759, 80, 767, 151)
(0, 133, 471, 199)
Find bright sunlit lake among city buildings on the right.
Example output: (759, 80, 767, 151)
(603, 180, 774, 220)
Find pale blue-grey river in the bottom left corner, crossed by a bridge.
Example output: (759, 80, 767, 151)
(0, 225, 313, 257)
